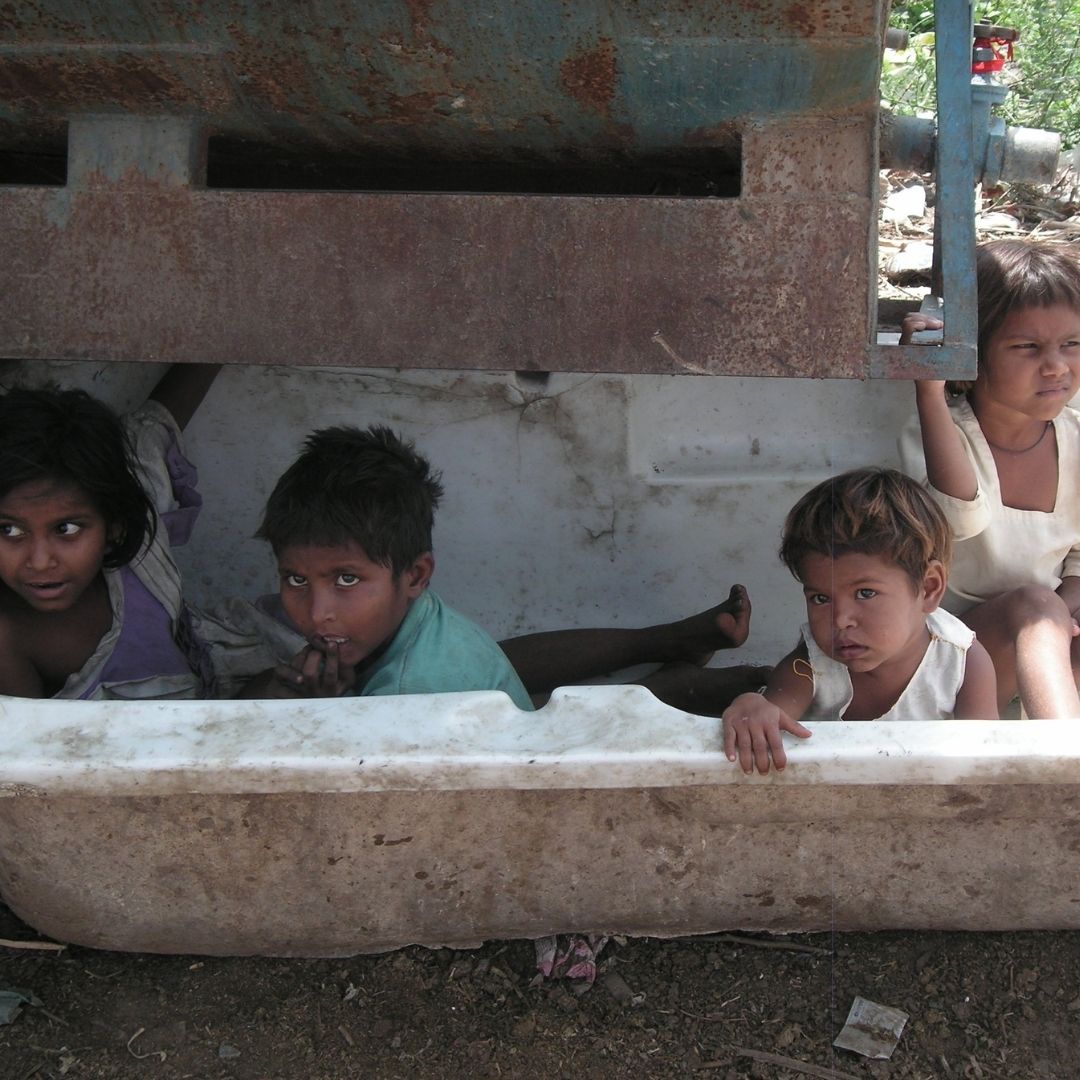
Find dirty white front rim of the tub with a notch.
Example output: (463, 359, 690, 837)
(0, 686, 1080, 797)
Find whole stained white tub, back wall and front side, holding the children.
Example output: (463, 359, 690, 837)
(0, 363, 1080, 955)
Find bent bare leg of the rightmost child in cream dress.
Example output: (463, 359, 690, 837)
(963, 585, 1080, 719)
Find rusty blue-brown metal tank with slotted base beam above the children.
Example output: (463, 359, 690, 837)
(0, 0, 959, 377)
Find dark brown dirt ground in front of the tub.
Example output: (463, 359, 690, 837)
(0, 907, 1080, 1080)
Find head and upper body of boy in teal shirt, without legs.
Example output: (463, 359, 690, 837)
(246, 427, 532, 708)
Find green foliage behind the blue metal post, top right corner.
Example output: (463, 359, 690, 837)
(881, 0, 1080, 147)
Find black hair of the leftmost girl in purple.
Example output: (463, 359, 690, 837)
(0, 389, 157, 569)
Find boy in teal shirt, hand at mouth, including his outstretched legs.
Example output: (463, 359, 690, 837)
(210, 416, 768, 715)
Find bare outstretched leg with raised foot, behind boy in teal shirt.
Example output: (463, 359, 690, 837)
(499, 585, 751, 693)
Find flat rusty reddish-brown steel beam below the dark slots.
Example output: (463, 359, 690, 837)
(0, 177, 869, 377)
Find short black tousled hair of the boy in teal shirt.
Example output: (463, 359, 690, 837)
(256, 427, 443, 575)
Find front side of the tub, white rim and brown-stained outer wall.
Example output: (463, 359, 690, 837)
(0, 686, 1080, 956)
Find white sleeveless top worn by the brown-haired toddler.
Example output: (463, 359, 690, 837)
(802, 608, 975, 724)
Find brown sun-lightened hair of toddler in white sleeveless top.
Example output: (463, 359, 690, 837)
(780, 468, 953, 584)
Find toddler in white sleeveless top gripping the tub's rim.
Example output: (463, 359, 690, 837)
(724, 469, 998, 772)
